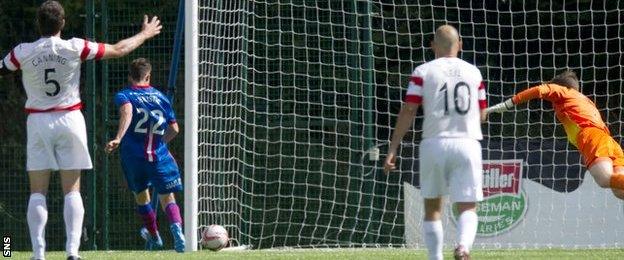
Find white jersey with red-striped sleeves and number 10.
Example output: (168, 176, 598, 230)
(405, 57, 487, 140)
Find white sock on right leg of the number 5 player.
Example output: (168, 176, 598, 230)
(63, 191, 84, 256)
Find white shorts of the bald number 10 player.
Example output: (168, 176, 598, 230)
(419, 138, 483, 202)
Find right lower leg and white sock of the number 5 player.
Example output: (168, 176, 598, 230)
(61, 170, 84, 257)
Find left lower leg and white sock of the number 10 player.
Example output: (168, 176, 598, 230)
(423, 197, 444, 260)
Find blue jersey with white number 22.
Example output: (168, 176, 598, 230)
(115, 86, 176, 162)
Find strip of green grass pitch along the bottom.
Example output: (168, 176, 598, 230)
(4, 249, 624, 260)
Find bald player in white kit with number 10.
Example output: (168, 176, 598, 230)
(384, 25, 487, 259)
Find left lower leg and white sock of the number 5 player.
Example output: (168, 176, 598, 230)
(26, 170, 50, 259)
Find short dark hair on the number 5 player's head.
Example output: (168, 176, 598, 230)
(37, 0, 65, 36)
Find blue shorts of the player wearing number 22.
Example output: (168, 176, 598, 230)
(121, 154, 182, 194)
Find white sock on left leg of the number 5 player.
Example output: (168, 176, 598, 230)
(26, 193, 48, 259)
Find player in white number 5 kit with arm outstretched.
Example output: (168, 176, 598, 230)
(0, 1, 162, 259)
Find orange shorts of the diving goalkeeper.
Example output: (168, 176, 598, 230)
(576, 127, 624, 168)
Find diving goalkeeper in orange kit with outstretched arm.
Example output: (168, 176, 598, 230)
(486, 71, 624, 200)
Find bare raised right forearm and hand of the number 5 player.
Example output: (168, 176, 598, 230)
(102, 15, 162, 59)
